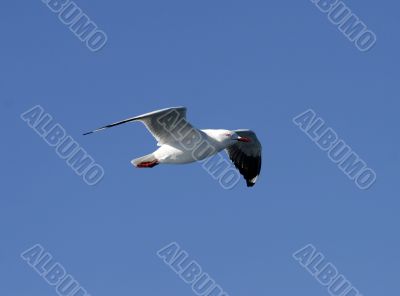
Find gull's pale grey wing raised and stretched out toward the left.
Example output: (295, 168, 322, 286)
(84, 107, 198, 145)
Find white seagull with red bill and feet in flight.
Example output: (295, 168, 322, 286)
(83, 107, 262, 187)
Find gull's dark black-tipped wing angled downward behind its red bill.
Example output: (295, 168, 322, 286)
(226, 130, 262, 187)
